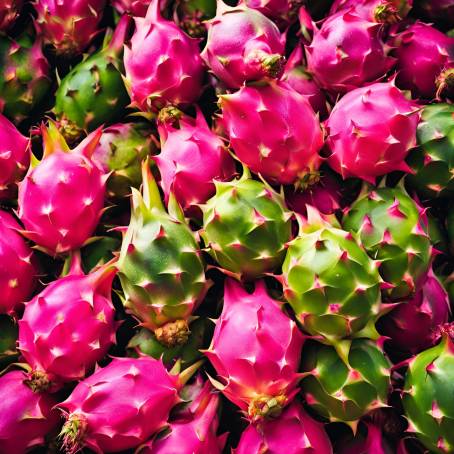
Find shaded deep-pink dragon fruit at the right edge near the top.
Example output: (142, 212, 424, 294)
(391, 22, 454, 99)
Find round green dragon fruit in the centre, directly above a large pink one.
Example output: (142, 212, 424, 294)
(201, 168, 292, 280)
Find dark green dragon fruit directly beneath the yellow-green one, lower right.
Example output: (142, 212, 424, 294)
(301, 339, 391, 427)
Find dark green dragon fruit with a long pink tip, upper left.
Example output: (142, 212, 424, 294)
(54, 16, 130, 142)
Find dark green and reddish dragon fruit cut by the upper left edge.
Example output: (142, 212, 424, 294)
(0, 34, 52, 123)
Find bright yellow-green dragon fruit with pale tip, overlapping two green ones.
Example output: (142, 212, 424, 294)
(279, 206, 381, 342)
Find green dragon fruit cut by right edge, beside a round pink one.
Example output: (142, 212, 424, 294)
(406, 104, 454, 198)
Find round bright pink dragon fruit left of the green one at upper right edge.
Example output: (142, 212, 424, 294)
(325, 83, 420, 184)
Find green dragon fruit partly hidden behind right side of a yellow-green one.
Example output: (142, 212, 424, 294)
(343, 188, 432, 300)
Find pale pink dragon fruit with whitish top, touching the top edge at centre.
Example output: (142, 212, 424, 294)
(202, 0, 285, 88)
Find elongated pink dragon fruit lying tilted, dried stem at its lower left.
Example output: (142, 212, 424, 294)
(58, 356, 182, 454)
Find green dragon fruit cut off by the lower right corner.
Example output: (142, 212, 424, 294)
(402, 324, 454, 453)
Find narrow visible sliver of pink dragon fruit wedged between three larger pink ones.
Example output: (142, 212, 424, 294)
(281, 45, 328, 120)
